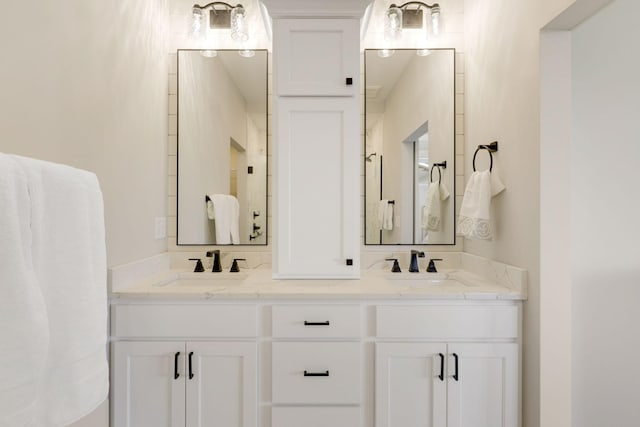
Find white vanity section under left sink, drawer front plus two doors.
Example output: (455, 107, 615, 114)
(111, 304, 258, 427)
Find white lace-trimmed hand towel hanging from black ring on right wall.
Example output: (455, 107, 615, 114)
(458, 170, 504, 240)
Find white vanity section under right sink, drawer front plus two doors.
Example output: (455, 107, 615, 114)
(375, 305, 520, 427)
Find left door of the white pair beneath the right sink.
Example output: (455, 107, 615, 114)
(376, 343, 447, 427)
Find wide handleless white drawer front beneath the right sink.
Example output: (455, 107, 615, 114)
(376, 306, 519, 339)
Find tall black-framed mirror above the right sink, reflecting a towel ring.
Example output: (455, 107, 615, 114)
(364, 49, 456, 245)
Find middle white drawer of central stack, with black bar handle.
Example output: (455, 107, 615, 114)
(272, 342, 361, 404)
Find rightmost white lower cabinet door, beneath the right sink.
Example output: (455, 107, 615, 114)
(448, 344, 520, 427)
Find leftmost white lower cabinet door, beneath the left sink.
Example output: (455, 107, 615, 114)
(111, 342, 185, 427)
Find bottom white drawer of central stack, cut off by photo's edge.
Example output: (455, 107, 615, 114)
(271, 406, 361, 427)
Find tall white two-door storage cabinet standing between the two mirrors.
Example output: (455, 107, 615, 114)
(273, 12, 360, 279)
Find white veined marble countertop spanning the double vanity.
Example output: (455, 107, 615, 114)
(110, 269, 526, 301)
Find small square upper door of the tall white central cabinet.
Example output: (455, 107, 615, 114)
(273, 19, 360, 96)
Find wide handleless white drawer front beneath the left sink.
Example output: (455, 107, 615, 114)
(111, 304, 258, 339)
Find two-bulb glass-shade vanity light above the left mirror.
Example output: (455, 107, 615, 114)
(191, 1, 249, 42)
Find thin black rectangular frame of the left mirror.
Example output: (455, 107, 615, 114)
(176, 49, 270, 248)
